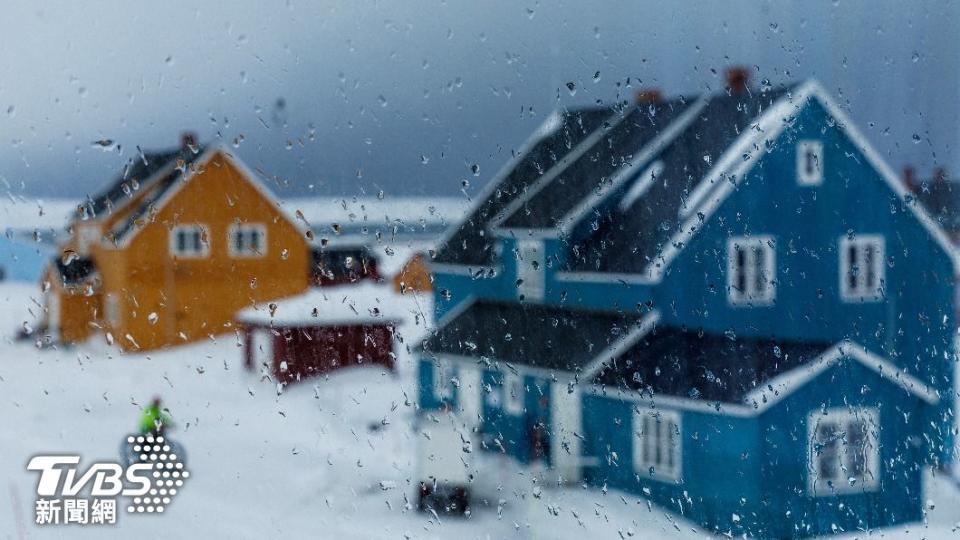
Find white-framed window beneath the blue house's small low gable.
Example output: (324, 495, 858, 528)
(808, 408, 880, 496)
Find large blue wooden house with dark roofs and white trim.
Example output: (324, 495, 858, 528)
(420, 70, 960, 537)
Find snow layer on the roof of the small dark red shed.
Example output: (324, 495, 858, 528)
(237, 282, 407, 326)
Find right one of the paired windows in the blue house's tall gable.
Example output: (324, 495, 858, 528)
(839, 234, 886, 302)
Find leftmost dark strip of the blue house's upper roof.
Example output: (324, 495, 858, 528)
(435, 107, 613, 265)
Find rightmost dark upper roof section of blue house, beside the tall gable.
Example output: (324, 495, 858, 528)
(568, 88, 789, 273)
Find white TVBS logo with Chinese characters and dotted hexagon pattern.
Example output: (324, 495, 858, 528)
(27, 435, 190, 525)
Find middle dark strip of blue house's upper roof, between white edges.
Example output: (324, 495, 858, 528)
(501, 98, 689, 229)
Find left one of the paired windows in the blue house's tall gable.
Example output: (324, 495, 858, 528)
(727, 235, 777, 305)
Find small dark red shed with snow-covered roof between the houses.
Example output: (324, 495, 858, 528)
(238, 283, 403, 383)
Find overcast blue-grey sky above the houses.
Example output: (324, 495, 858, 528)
(0, 0, 960, 197)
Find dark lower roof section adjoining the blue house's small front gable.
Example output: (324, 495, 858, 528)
(592, 326, 833, 403)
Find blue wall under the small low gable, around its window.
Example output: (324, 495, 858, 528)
(757, 360, 929, 537)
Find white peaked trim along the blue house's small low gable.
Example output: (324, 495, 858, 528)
(744, 341, 940, 412)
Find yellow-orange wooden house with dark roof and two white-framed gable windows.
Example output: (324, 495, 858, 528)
(42, 137, 310, 350)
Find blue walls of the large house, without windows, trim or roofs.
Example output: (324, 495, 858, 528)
(420, 84, 957, 537)
